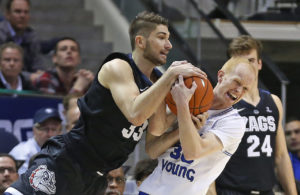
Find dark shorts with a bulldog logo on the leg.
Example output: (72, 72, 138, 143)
(12, 136, 107, 195)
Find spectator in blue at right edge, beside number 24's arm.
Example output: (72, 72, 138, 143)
(285, 118, 300, 181)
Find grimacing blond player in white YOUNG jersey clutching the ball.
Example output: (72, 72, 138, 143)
(139, 58, 255, 195)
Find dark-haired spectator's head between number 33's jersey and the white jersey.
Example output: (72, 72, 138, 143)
(134, 159, 158, 187)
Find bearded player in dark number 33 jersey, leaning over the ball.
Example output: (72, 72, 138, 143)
(6, 12, 206, 195)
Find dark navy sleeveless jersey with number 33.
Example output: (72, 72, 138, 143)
(65, 53, 161, 172)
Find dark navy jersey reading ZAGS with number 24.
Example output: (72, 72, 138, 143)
(216, 89, 279, 191)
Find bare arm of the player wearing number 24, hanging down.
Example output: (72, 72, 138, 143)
(272, 94, 297, 194)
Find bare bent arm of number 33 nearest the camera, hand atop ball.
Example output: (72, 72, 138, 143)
(98, 59, 203, 126)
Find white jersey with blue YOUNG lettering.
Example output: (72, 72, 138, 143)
(139, 107, 246, 195)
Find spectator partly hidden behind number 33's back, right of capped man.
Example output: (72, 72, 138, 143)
(63, 93, 81, 132)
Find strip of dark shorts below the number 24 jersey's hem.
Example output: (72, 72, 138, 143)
(216, 186, 274, 195)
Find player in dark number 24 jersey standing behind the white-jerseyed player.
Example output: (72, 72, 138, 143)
(216, 35, 297, 195)
